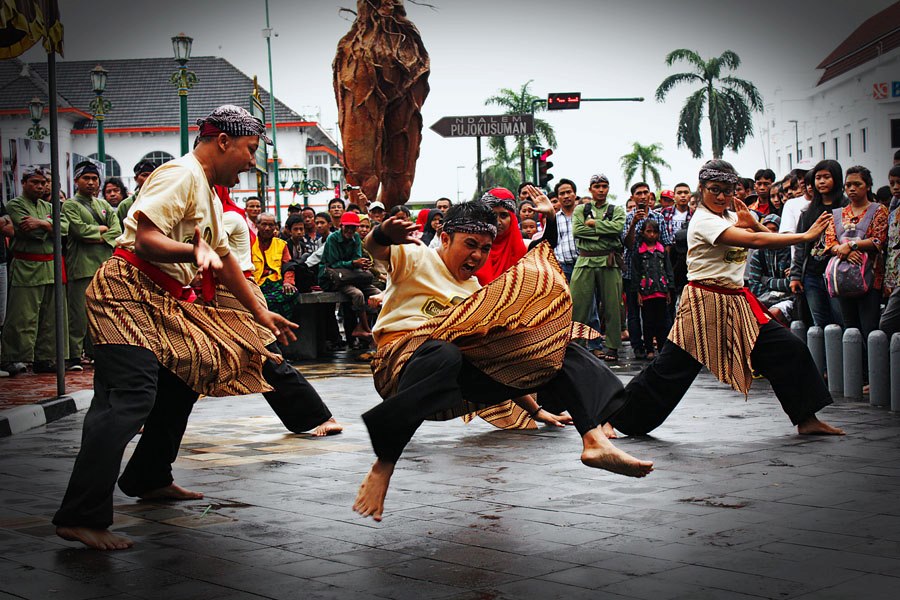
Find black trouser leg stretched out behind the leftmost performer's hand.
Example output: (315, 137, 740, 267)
(263, 342, 331, 433)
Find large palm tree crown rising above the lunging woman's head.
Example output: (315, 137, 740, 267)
(656, 49, 763, 158)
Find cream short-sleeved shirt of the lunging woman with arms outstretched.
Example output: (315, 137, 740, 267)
(687, 205, 747, 287)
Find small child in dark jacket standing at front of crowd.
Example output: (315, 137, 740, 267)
(631, 219, 675, 359)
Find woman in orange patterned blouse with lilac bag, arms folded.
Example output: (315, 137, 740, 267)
(825, 166, 888, 342)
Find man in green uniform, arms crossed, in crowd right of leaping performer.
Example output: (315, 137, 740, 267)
(570, 175, 625, 361)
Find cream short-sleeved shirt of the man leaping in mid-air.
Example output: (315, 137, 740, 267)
(372, 244, 481, 342)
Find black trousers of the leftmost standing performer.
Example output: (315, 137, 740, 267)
(53, 344, 198, 529)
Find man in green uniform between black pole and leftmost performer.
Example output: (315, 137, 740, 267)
(62, 161, 122, 371)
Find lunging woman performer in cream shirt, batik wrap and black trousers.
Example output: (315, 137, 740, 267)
(610, 159, 844, 435)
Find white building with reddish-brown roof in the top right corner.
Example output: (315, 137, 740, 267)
(766, 3, 900, 188)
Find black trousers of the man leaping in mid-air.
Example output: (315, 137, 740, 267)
(363, 340, 624, 463)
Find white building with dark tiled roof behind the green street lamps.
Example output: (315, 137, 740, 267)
(0, 56, 340, 213)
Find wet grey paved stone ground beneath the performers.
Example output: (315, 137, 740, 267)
(0, 369, 900, 600)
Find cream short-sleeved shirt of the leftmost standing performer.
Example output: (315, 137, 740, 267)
(116, 153, 230, 285)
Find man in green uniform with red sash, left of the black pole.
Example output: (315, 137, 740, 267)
(0, 166, 67, 375)
